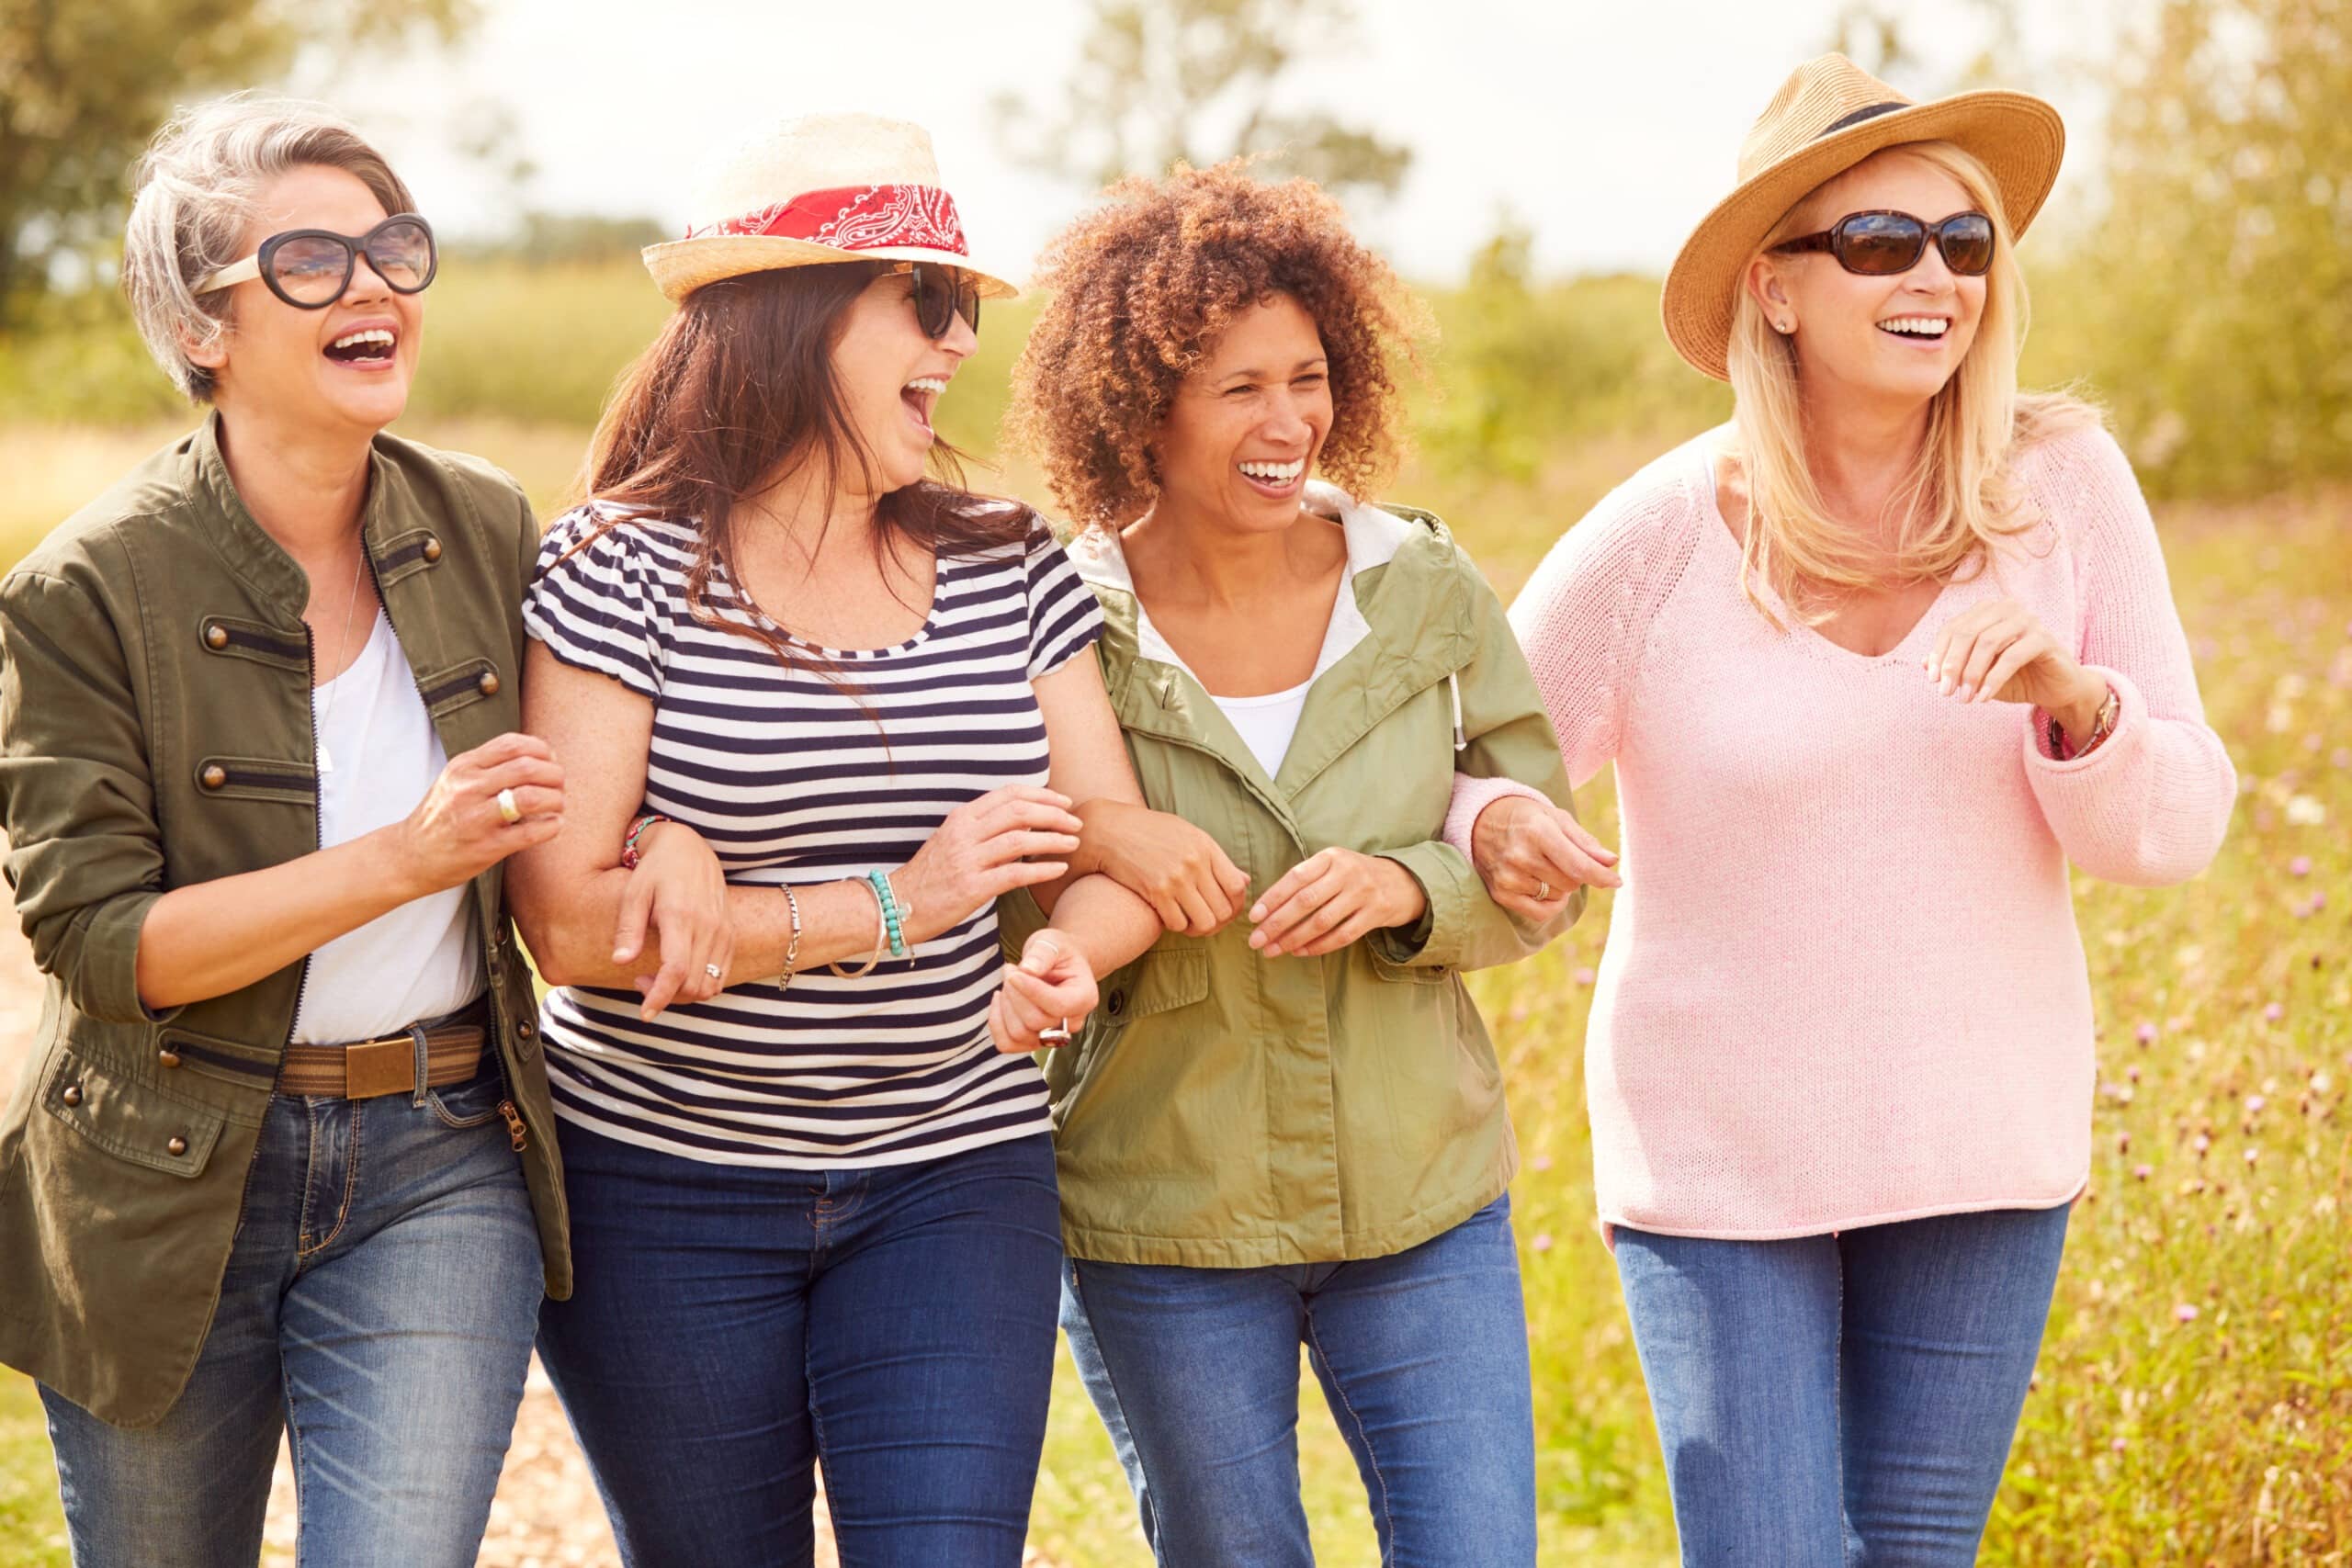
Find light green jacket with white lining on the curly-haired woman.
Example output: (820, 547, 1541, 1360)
(1004, 487, 1583, 1267)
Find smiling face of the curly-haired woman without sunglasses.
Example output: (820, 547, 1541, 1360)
(1152, 294, 1331, 531)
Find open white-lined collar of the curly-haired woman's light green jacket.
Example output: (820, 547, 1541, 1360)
(1070, 482, 1475, 820)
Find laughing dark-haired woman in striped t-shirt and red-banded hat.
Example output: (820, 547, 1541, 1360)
(513, 115, 1159, 1568)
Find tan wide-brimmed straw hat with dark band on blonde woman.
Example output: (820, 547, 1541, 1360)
(1660, 54, 2065, 381)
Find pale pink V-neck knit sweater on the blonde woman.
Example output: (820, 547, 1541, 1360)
(1446, 430, 2237, 1239)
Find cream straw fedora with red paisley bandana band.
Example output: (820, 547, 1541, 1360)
(644, 115, 1021, 299)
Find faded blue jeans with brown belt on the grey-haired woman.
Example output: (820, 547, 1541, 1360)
(42, 1065, 541, 1568)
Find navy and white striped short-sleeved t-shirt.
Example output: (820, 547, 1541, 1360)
(522, 505, 1103, 1168)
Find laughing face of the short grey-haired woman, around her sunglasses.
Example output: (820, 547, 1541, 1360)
(188, 164, 424, 434)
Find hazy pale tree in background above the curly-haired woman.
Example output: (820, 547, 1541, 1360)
(995, 0, 1414, 195)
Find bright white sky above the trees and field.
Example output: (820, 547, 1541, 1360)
(317, 0, 2133, 280)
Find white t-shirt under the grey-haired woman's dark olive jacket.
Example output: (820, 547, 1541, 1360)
(294, 609, 482, 1046)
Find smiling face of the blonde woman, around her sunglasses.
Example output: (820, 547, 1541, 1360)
(1747, 148, 1985, 404)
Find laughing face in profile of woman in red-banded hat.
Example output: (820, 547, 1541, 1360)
(832, 273, 978, 493)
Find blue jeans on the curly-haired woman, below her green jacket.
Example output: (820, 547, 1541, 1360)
(1061, 1194, 1536, 1568)
